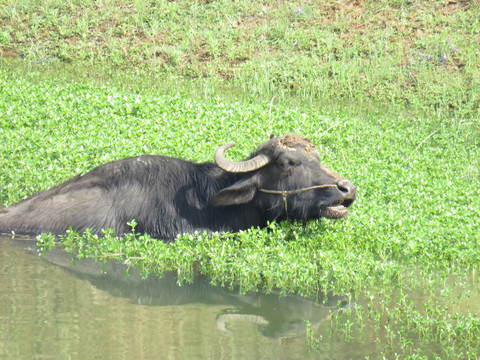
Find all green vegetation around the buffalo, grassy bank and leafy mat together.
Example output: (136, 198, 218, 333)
(0, 0, 480, 359)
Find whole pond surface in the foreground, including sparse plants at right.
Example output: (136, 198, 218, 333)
(0, 236, 480, 359)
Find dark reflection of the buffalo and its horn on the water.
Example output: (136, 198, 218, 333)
(41, 240, 345, 338)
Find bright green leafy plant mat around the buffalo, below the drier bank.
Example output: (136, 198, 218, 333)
(0, 67, 480, 358)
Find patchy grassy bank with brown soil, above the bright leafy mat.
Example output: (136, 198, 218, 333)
(0, 0, 480, 117)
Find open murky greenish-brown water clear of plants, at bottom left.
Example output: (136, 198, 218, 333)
(0, 237, 352, 359)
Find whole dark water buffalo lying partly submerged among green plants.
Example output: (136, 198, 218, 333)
(0, 134, 356, 240)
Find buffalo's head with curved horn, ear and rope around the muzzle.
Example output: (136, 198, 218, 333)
(213, 134, 356, 221)
